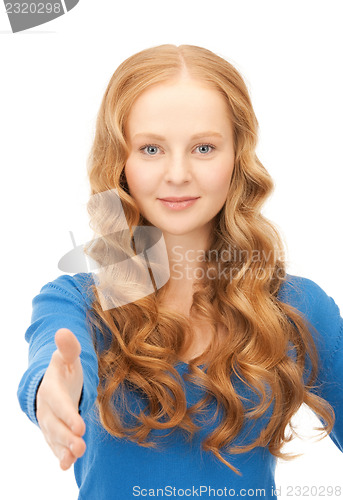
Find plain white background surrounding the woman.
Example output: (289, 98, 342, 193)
(0, 0, 343, 500)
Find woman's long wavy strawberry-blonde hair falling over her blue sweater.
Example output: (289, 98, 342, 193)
(85, 44, 335, 475)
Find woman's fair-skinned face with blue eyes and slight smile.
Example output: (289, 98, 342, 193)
(125, 79, 234, 239)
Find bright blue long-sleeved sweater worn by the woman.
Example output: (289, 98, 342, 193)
(18, 273, 343, 500)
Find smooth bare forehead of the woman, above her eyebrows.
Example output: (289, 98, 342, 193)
(126, 79, 231, 134)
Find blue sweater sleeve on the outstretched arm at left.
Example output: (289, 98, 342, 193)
(17, 273, 99, 426)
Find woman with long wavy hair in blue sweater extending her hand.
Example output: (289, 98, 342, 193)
(18, 45, 343, 499)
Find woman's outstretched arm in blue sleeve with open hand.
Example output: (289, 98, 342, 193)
(18, 274, 99, 469)
